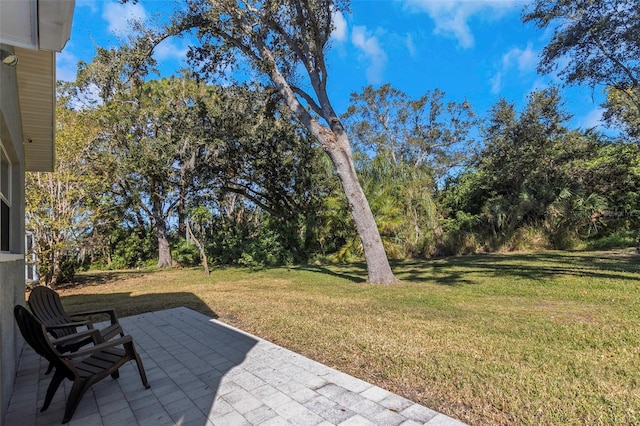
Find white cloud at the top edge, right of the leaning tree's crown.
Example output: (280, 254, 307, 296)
(403, 0, 522, 49)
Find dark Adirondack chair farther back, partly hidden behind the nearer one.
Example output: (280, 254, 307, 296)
(27, 286, 124, 374)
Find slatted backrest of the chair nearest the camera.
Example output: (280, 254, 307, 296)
(13, 305, 73, 377)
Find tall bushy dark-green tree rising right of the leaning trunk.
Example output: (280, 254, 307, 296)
(440, 88, 608, 249)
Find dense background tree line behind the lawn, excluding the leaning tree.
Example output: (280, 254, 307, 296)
(27, 80, 640, 283)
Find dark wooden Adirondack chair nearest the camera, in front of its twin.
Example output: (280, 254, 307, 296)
(13, 305, 150, 423)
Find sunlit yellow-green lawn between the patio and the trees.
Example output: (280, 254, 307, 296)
(53, 252, 640, 425)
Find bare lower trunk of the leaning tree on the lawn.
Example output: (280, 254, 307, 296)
(321, 128, 398, 285)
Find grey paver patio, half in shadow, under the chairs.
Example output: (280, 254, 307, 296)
(5, 308, 463, 426)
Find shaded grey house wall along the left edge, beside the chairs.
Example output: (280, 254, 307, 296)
(0, 45, 25, 424)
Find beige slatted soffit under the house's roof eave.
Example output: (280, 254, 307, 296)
(15, 47, 56, 172)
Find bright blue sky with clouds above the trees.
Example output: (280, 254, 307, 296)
(58, 0, 603, 128)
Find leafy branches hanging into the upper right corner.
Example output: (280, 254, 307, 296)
(523, 0, 640, 140)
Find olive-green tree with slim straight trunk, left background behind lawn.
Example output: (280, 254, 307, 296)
(85, 73, 210, 267)
